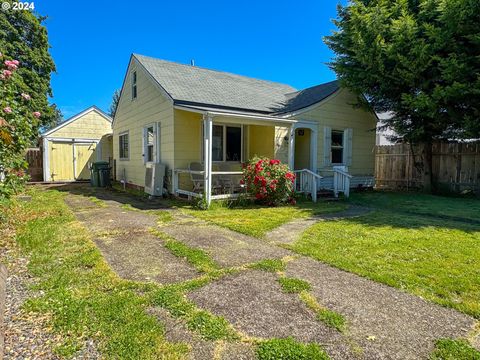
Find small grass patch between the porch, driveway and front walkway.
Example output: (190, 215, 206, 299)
(182, 200, 348, 238)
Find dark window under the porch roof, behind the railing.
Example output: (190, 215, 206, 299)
(208, 125, 242, 162)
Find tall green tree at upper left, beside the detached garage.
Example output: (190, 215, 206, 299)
(0, 0, 57, 127)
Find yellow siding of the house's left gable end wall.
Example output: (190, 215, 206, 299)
(113, 60, 174, 186)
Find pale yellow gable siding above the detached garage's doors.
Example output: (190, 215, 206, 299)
(48, 110, 112, 140)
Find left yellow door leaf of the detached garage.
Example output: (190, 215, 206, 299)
(48, 141, 74, 181)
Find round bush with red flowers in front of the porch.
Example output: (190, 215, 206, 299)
(242, 157, 295, 206)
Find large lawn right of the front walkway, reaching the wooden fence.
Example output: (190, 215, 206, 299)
(291, 193, 480, 319)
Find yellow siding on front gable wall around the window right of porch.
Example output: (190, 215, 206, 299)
(295, 89, 377, 175)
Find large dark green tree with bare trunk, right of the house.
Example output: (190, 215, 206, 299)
(325, 0, 480, 191)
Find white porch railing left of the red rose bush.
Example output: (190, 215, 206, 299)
(173, 169, 244, 200)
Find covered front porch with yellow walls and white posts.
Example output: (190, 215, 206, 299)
(172, 107, 349, 205)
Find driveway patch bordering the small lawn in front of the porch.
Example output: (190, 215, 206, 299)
(161, 215, 292, 267)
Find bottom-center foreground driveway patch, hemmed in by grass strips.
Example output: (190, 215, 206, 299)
(188, 271, 355, 359)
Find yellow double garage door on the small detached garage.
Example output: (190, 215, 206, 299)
(49, 141, 96, 181)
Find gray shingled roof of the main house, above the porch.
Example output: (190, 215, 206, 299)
(133, 54, 338, 114)
